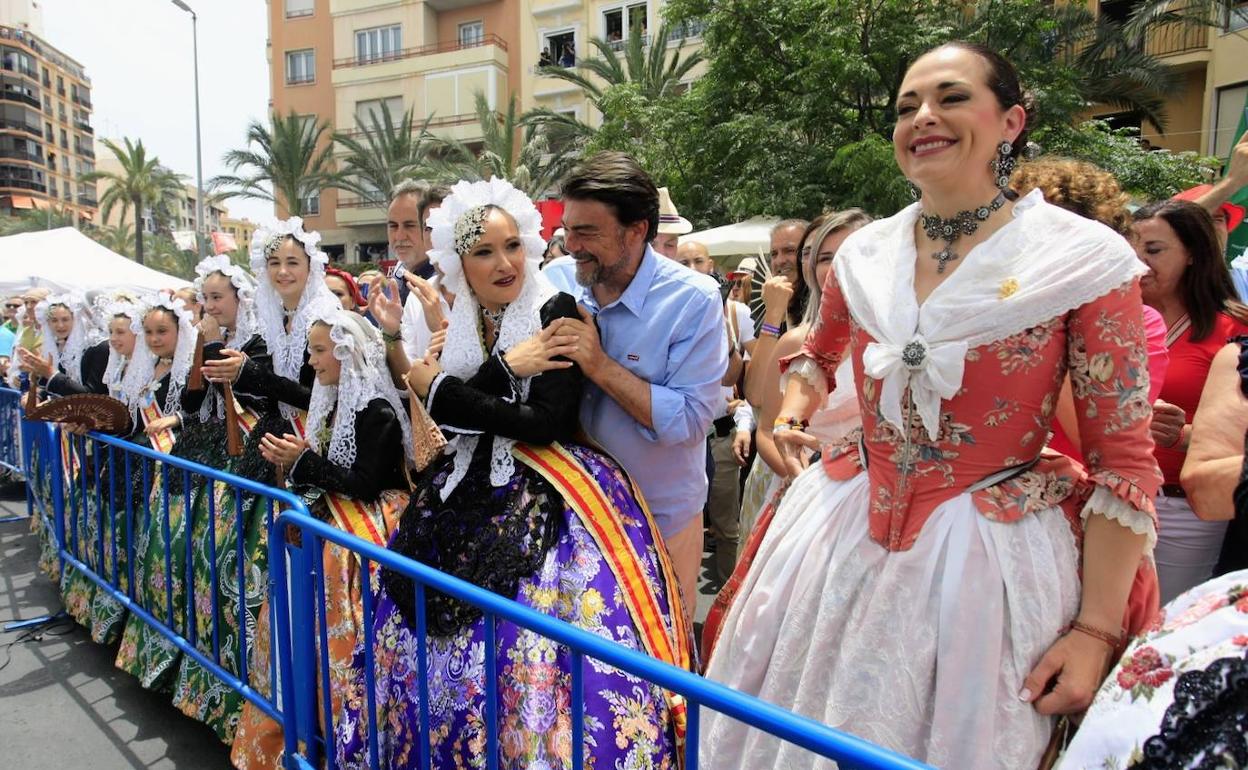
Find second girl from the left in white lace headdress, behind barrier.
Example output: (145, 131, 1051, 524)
(54, 301, 139, 633)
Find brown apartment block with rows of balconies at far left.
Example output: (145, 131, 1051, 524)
(0, 24, 99, 221)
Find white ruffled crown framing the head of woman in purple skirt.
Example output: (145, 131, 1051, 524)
(429, 177, 545, 297)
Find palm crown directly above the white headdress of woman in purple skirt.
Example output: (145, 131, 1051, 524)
(431, 91, 578, 198)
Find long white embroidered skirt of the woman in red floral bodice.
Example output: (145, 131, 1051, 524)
(700, 465, 1080, 770)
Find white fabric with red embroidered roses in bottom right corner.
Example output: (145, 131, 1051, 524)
(1058, 570, 1248, 770)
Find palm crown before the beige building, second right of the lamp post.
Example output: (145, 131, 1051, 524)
(332, 101, 434, 203)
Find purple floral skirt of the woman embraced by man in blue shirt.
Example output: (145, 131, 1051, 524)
(336, 447, 683, 770)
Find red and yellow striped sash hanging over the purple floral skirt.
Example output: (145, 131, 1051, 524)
(512, 443, 693, 766)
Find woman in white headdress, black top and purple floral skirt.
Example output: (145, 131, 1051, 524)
(336, 178, 691, 768)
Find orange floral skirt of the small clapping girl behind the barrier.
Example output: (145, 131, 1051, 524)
(230, 490, 408, 770)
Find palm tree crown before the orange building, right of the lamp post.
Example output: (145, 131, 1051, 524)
(208, 110, 334, 216)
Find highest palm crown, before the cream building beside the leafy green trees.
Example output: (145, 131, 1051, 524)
(525, 21, 705, 137)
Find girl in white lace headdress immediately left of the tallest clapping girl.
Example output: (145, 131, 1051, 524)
(173, 256, 277, 743)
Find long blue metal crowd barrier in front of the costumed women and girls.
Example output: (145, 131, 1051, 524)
(12, 399, 926, 770)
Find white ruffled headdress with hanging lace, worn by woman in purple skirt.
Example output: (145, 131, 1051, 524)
(429, 177, 555, 500)
